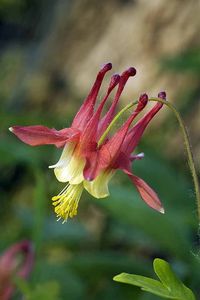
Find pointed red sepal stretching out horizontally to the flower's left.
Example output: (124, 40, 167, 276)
(10, 125, 79, 147)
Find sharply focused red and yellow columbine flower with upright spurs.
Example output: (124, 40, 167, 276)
(10, 63, 166, 221)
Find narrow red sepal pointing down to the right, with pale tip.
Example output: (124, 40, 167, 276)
(123, 169, 164, 213)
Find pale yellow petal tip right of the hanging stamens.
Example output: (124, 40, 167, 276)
(83, 171, 114, 198)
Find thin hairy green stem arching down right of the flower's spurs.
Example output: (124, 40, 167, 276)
(149, 98, 200, 222)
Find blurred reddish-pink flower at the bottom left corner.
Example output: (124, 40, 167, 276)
(0, 241, 34, 300)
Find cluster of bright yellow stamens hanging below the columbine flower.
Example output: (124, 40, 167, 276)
(52, 183, 83, 223)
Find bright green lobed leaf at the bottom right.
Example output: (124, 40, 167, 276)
(113, 258, 195, 300)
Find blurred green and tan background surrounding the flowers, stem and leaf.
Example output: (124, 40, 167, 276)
(0, 0, 200, 300)
